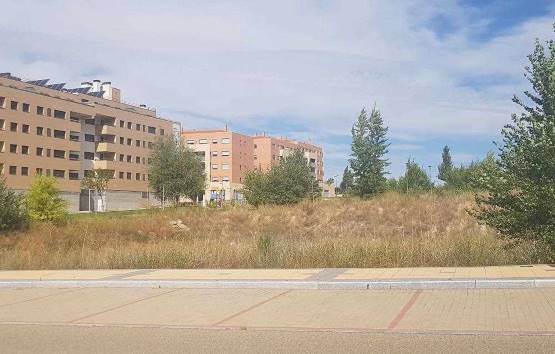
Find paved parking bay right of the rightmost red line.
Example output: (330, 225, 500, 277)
(397, 288, 555, 332)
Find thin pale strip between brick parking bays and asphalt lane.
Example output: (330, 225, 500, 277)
(0, 321, 555, 337)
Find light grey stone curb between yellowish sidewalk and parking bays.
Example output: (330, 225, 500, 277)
(0, 278, 555, 290)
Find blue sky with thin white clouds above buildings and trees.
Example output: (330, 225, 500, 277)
(0, 0, 555, 178)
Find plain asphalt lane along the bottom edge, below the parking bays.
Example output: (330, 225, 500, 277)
(0, 325, 555, 353)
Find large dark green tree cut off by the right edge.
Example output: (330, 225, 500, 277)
(473, 27, 555, 251)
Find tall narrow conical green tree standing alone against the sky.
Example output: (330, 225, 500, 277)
(350, 107, 389, 197)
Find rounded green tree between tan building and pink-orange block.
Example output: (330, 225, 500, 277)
(148, 137, 205, 203)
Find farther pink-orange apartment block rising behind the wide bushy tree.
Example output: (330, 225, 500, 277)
(253, 135, 324, 183)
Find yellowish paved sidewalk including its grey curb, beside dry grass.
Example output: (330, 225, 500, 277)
(0, 265, 555, 289)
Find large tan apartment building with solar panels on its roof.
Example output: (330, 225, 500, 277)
(0, 73, 181, 211)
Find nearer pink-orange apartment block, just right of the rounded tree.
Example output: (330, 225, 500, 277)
(181, 129, 254, 201)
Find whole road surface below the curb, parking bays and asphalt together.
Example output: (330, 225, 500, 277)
(0, 288, 555, 353)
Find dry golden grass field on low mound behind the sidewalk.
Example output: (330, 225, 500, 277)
(0, 194, 550, 269)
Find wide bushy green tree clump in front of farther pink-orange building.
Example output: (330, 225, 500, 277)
(243, 150, 322, 206)
